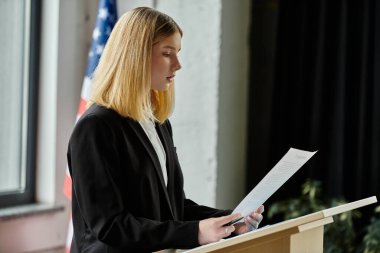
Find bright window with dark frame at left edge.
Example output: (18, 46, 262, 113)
(0, 0, 41, 207)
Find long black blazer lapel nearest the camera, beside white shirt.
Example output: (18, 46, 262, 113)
(131, 121, 174, 218)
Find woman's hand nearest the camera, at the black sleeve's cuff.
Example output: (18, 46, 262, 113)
(198, 214, 241, 245)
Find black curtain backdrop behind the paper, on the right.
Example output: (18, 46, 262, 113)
(246, 0, 380, 231)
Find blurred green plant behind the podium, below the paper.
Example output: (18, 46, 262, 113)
(268, 179, 360, 253)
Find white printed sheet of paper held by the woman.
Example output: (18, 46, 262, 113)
(233, 148, 317, 217)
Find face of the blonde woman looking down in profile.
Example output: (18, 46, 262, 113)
(152, 32, 181, 91)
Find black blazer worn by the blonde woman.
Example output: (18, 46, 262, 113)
(67, 105, 231, 253)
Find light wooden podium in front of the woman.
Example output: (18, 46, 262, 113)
(162, 196, 377, 253)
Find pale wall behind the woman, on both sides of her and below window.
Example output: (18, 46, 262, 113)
(0, 0, 249, 252)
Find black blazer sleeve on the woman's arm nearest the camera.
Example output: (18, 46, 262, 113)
(68, 116, 199, 251)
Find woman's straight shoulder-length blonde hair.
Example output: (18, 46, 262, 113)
(88, 7, 182, 123)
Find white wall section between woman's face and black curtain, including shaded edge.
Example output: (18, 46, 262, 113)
(153, 0, 250, 209)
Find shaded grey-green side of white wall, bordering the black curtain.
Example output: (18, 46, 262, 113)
(216, 0, 251, 208)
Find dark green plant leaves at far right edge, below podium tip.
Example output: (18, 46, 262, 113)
(363, 206, 380, 253)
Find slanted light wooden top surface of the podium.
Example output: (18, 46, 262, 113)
(182, 196, 377, 253)
